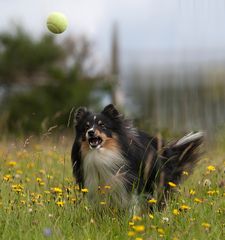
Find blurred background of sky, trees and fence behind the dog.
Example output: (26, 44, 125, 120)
(0, 0, 225, 137)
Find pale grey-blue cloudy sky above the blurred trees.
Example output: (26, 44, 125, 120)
(0, 0, 225, 65)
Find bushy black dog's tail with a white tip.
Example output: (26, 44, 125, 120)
(159, 132, 204, 205)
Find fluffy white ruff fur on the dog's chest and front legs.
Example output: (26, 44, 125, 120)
(83, 148, 128, 206)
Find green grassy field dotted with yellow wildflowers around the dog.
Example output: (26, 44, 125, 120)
(0, 135, 225, 240)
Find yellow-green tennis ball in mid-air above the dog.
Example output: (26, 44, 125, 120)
(47, 12, 68, 34)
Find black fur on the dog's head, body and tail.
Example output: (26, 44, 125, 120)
(72, 104, 203, 209)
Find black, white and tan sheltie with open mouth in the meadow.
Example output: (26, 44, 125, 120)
(72, 104, 203, 207)
